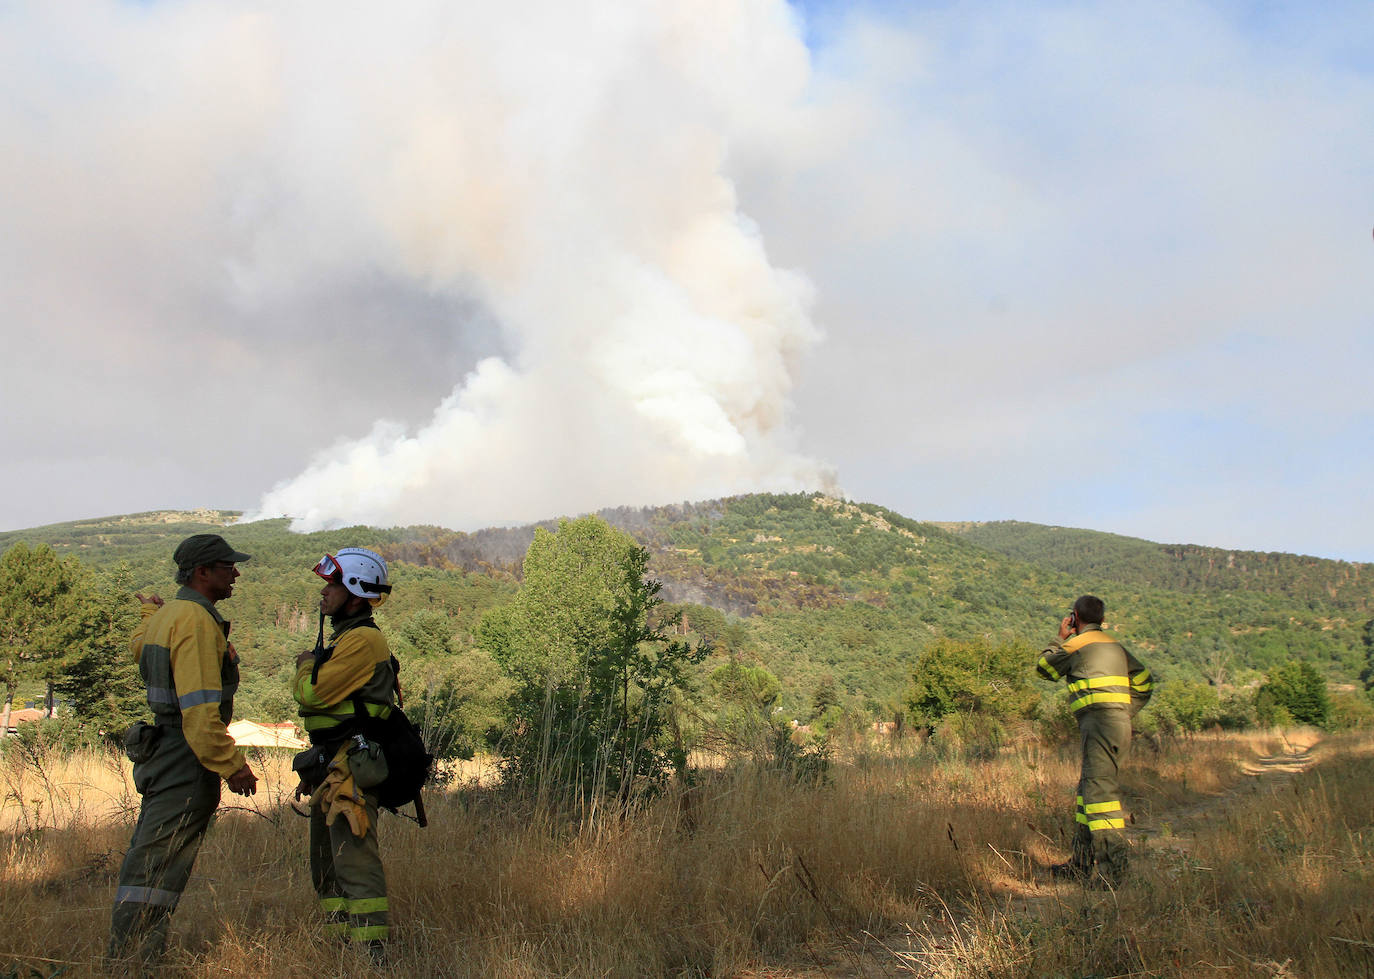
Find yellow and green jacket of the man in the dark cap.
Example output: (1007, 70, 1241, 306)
(129, 588, 246, 779)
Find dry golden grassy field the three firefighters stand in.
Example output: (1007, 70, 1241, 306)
(0, 732, 1374, 979)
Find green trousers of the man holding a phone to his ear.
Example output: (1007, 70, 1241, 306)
(1073, 707, 1131, 882)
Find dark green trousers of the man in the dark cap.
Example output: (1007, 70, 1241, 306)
(110, 726, 221, 961)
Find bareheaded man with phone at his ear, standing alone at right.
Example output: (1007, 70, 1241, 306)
(1036, 595, 1153, 886)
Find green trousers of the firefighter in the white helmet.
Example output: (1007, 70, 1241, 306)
(311, 792, 390, 942)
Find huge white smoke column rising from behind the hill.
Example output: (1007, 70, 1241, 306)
(232, 0, 826, 530)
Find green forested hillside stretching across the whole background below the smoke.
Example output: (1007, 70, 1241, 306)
(0, 493, 1374, 715)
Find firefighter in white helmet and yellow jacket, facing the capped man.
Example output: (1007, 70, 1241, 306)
(291, 548, 397, 958)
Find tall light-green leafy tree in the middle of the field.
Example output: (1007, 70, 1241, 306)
(478, 518, 709, 810)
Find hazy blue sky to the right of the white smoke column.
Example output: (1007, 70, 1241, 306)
(782, 3, 1374, 560)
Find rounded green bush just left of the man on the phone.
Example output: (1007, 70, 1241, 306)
(905, 638, 1039, 728)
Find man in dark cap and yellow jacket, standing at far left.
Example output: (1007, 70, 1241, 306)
(109, 534, 257, 961)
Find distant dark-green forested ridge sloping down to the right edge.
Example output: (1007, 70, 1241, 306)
(941, 520, 1374, 615)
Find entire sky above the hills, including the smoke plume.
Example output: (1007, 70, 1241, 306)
(0, 0, 1374, 560)
